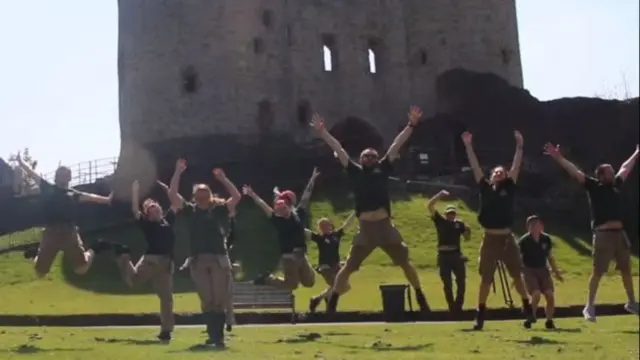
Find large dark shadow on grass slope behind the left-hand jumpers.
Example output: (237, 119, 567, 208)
(62, 199, 280, 295)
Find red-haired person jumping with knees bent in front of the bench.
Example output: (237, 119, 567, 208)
(242, 185, 316, 291)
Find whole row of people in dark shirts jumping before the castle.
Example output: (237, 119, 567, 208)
(12, 106, 638, 347)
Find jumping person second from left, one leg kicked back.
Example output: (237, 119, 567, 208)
(113, 181, 180, 341)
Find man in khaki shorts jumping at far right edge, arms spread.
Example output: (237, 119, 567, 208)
(545, 143, 638, 321)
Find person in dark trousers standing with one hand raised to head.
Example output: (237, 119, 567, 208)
(427, 190, 471, 313)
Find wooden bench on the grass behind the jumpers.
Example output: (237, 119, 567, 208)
(233, 282, 296, 324)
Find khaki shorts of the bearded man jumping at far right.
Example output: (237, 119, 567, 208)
(593, 230, 631, 275)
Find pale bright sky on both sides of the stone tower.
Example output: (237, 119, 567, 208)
(0, 0, 640, 171)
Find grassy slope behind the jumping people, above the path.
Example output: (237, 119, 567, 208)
(0, 197, 638, 314)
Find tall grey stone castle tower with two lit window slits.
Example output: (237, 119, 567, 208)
(118, 0, 522, 173)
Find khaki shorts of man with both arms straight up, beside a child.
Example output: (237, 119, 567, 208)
(479, 232, 522, 282)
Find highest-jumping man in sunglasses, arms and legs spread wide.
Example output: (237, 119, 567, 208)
(311, 106, 429, 313)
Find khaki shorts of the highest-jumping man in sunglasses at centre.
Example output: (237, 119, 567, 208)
(345, 218, 409, 271)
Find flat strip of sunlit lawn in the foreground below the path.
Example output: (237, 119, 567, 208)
(0, 316, 640, 360)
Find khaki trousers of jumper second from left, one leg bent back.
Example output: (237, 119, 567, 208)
(118, 254, 175, 331)
